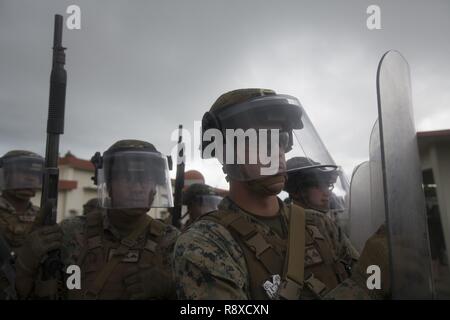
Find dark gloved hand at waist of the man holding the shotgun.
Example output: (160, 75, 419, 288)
(124, 265, 176, 300)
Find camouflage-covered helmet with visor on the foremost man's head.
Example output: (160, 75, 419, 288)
(202, 89, 303, 181)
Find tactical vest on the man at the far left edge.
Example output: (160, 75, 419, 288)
(0, 201, 36, 249)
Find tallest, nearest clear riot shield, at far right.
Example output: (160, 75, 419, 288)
(377, 51, 433, 299)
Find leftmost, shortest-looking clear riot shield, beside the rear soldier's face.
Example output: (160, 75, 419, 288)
(349, 161, 373, 252)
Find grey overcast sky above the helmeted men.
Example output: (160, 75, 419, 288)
(0, 0, 450, 187)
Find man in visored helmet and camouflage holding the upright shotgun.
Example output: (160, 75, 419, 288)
(17, 140, 178, 300)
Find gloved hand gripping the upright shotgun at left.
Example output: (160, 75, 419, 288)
(17, 225, 63, 273)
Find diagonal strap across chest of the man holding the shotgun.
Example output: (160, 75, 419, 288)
(81, 215, 152, 299)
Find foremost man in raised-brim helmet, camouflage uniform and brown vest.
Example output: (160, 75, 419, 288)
(173, 89, 382, 300)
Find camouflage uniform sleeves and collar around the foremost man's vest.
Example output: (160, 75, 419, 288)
(174, 198, 358, 299)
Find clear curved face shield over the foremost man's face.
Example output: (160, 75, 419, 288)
(203, 95, 303, 181)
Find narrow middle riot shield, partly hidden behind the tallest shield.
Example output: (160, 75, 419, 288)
(369, 120, 386, 234)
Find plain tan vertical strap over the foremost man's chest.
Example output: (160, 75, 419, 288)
(278, 205, 306, 299)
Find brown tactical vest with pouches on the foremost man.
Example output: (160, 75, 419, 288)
(202, 206, 348, 300)
